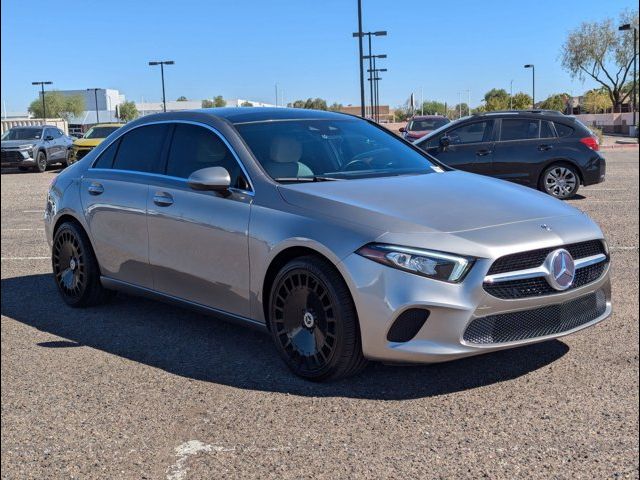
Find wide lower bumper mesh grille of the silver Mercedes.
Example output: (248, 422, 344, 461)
(463, 290, 607, 345)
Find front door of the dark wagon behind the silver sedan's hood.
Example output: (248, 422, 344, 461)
(420, 118, 495, 175)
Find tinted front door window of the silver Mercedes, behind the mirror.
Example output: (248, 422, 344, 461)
(166, 123, 248, 189)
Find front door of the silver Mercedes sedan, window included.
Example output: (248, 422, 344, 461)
(147, 123, 253, 317)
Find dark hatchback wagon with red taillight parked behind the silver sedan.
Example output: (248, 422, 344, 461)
(416, 110, 606, 199)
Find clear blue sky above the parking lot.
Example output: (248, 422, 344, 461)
(0, 0, 637, 111)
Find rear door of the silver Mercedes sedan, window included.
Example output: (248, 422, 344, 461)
(80, 124, 169, 288)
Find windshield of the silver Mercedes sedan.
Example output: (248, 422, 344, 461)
(236, 119, 440, 182)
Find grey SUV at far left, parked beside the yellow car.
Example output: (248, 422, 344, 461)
(1, 125, 73, 172)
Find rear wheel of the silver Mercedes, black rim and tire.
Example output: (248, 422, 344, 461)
(51, 222, 113, 308)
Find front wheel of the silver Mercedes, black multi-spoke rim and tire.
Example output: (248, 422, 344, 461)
(269, 256, 367, 382)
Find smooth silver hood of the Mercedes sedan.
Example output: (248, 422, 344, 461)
(279, 171, 582, 233)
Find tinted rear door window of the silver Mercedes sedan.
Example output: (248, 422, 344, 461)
(113, 123, 169, 172)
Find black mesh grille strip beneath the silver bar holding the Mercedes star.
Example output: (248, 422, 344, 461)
(484, 262, 608, 300)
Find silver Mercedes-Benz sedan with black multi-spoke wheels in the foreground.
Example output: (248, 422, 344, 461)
(45, 108, 611, 380)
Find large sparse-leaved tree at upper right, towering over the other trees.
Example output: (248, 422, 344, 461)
(560, 10, 638, 110)
